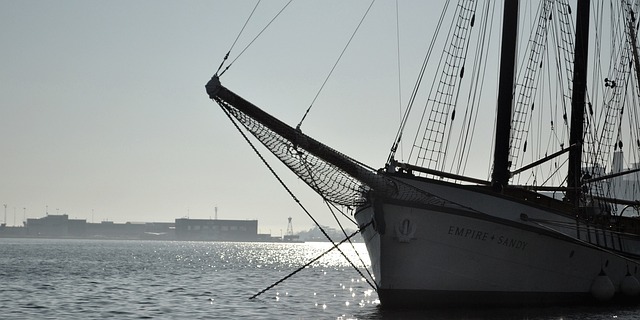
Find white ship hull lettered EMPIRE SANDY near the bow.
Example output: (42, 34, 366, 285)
(355, 175, 640, 307)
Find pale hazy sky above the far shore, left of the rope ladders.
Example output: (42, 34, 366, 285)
(0, 0, 502, 235)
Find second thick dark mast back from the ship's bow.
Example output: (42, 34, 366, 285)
(567, 0, 590, 208)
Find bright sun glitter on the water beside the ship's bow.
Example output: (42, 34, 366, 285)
(168, 242, 379, 319)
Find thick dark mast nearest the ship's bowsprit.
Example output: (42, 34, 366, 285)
(491, 0, 519, 190)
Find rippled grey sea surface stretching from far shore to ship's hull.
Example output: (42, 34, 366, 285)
(0, 239, 640, 319)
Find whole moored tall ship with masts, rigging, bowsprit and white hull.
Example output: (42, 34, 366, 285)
(206, 0, 640, 308)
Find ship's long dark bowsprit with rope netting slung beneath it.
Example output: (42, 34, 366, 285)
(207, 77, 463, 208)
